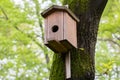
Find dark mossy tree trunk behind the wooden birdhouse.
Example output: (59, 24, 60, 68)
(50, 0, 107, 80)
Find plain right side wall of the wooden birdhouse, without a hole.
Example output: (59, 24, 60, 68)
(64, 12, 77, 48)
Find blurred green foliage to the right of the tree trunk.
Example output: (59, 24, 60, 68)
(96, 0, 120, 80)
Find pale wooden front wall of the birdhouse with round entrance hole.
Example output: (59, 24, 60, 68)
(45, 11, 63, 42)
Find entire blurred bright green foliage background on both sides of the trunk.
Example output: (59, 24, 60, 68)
(0, 0, 120, 80)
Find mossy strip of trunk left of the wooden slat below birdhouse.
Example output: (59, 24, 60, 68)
(50, 53, 65, 80)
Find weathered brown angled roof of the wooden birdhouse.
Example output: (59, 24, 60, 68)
(41, 5, 79, 22)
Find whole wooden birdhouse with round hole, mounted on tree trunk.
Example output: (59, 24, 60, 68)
(41, 5, 79, 53)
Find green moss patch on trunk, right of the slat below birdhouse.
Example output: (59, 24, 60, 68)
(71, 50, 94, 80)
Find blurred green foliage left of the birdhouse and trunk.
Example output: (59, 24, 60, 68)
(0, 0, 52, 80)
